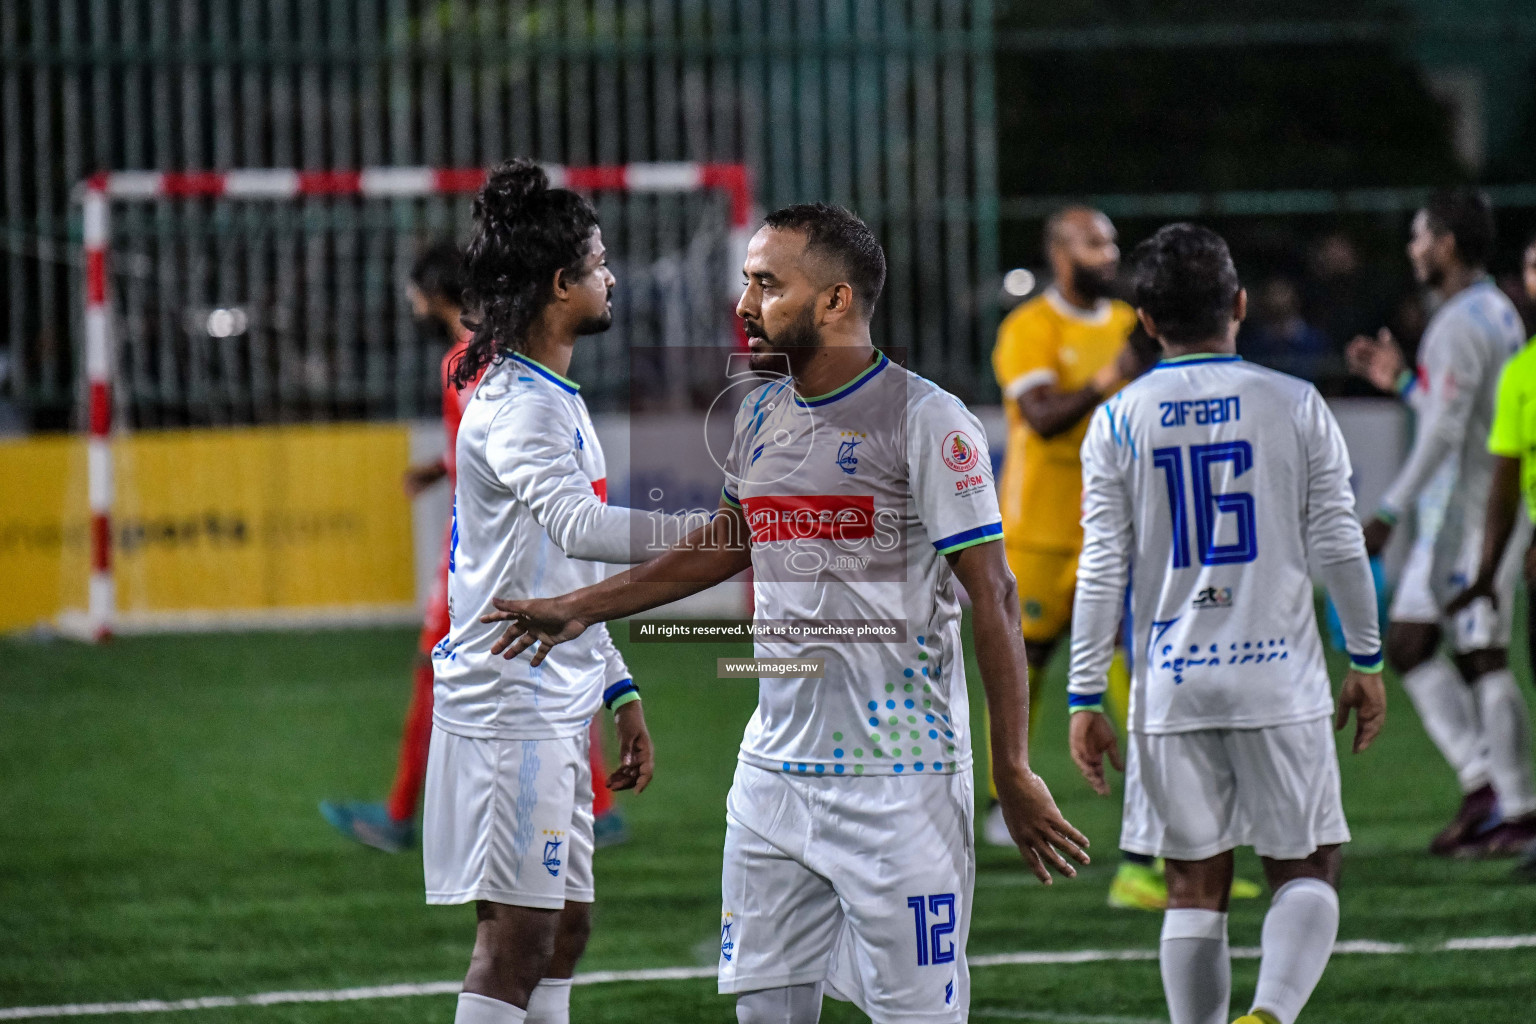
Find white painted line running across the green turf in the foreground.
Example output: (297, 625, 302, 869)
(0, 935, 1536, 1024)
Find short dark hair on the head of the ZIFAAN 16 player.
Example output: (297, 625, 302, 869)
(1130, 224, 1243, 345)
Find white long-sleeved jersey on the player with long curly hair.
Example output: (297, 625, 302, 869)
(432, 355, 672, 740)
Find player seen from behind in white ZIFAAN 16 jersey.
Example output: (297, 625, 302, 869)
(1069, 224, 1385, 1024)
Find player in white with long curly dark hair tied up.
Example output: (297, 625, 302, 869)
(422, 160, 680, 1024)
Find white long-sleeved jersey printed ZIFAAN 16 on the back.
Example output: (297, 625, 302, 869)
(1069, 355, 1381, 734)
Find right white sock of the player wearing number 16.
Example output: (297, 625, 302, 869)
(1253, 878, 1339, 1024)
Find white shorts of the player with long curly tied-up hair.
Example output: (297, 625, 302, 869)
(421, 723, 593, 910)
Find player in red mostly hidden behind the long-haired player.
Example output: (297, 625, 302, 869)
(319, 241, 627, 854)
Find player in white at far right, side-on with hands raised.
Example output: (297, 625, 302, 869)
(1347, 189, 1536, 857)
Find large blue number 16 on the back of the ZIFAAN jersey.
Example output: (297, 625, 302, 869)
(1152, 441, 1258, 570)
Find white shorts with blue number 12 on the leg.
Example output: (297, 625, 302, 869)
(720, 763, 975, 1024)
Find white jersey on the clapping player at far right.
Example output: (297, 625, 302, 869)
(1381, 279, 1525, 543)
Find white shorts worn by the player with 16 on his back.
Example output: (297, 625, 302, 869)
(1120, 718, 1349, 860)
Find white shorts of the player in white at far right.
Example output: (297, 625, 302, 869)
(1387, 516, 1530, 654)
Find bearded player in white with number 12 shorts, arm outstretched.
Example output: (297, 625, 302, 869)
(485, 204, 1087, 1024)
